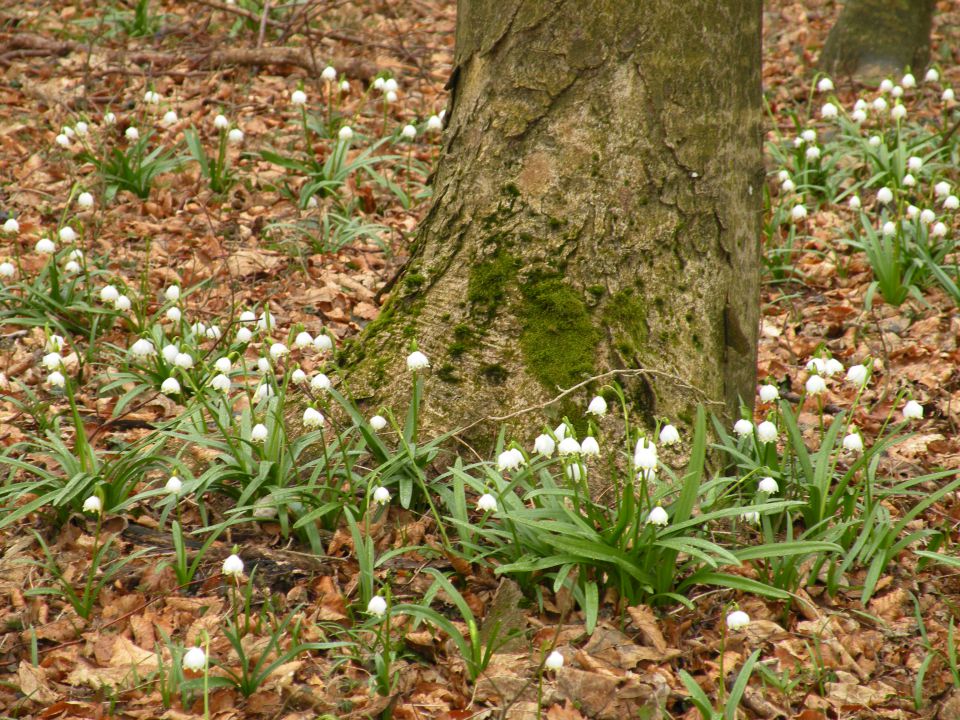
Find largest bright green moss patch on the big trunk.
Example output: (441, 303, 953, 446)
(520, 276, 600, 392)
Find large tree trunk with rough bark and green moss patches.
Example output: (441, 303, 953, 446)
(345, 0, 764, 444)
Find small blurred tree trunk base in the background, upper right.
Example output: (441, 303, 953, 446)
(820, 0, 936, 81)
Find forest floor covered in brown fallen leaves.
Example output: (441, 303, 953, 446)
(0, 0, 960, 720)
